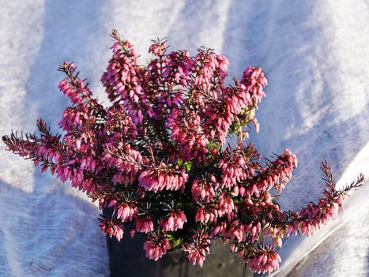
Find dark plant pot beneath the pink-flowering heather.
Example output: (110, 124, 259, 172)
(106, 224, 253, 277)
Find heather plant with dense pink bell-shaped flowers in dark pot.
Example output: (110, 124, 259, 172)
(3, 31, 364, 273)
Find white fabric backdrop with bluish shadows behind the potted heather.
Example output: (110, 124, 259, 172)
(0, 0, 369, 276)
